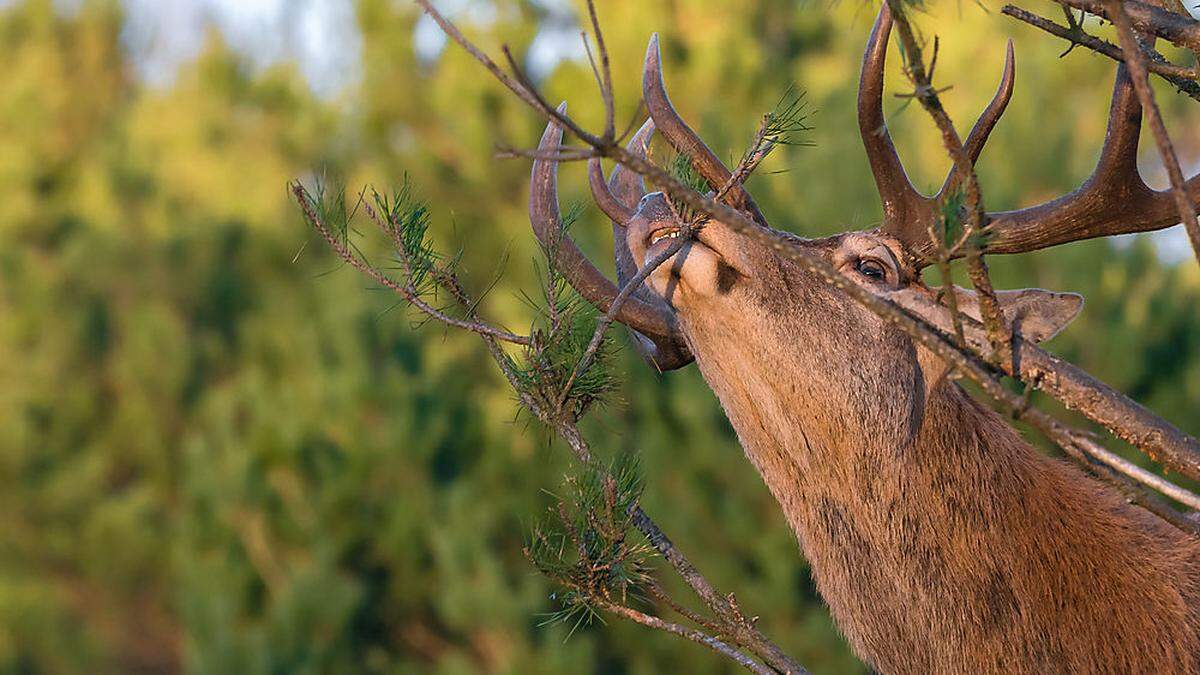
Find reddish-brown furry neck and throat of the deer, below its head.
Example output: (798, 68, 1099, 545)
(697, 329, 1200, 671)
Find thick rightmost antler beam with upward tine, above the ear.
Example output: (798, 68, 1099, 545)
(988, 64, 1200, 253)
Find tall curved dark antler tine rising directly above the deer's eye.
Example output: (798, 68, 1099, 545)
(858, 2, 934, 245)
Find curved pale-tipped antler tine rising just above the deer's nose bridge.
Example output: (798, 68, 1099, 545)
(642, 32, 767, 227)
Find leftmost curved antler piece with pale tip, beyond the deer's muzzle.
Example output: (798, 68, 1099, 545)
(529, 103, 692, 370)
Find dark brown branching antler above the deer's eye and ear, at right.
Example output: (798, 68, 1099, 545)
(858, 2, 1200, 264)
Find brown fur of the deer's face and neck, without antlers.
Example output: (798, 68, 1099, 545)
(629, 223, 1200, 673)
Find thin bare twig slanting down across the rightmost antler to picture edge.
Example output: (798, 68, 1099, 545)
(1105, 0, 1200, 262)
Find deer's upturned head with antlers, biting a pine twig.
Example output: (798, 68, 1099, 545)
(530, 5, 1198, 417)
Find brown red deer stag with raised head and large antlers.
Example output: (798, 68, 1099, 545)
(529, 4, 1200, 673)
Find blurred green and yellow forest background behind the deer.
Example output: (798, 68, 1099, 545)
(0, 0, 1200, 674)
